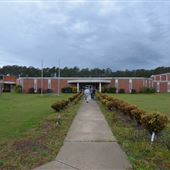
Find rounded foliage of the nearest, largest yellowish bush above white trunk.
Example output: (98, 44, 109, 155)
(141, 112, 168, 134)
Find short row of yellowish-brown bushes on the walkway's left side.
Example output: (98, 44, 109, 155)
(51, 93, 83, 112)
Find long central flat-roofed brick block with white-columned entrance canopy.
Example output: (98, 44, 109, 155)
(17, 77, 152, 93)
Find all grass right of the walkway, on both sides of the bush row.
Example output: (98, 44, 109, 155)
(100, 94, 170, 170)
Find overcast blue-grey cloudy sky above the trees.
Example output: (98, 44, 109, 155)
(0, 0, 170, 70)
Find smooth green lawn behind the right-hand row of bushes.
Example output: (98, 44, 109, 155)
(109, 93, 170, 118)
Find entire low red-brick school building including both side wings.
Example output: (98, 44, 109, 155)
(0, 73, 170, 93)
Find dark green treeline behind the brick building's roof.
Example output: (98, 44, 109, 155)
(0, 65, 170, 77)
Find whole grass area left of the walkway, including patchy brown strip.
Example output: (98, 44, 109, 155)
(0, 93, 81, 170)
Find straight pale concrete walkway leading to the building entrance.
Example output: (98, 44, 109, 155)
(35, 100, 130, 170)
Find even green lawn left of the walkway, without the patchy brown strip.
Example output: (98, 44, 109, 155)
(0, 93, 71, 143)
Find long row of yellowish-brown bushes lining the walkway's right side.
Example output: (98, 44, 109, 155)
(96, 93, 168, 134)
